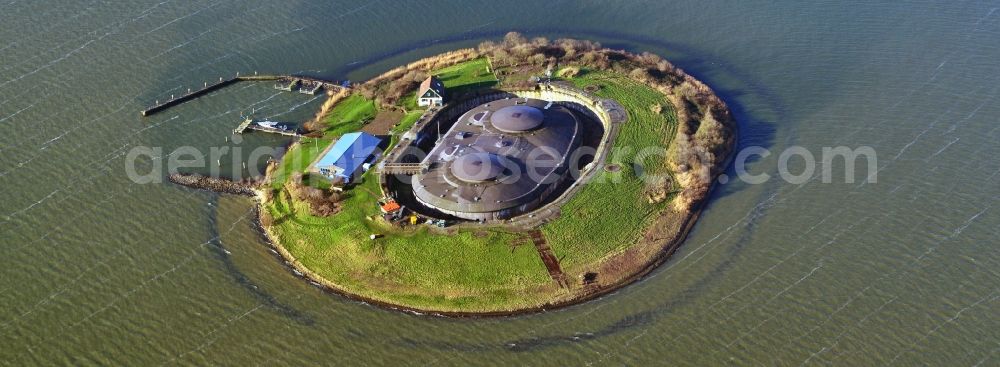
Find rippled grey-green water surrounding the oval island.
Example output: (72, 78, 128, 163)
(0, 0, 1000, 366)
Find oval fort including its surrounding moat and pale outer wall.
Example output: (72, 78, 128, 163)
(379, 83, 628, 227)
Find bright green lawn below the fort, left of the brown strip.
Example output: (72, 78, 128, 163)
(267, 172, 551, 309)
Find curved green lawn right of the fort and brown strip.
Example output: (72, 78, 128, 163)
(542, 72, 677, 273)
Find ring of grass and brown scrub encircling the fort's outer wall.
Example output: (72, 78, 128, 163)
(260, 33, 734, 314)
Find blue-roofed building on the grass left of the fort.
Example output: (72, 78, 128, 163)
(312, 132, 382, 183)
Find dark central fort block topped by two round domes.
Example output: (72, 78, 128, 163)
(412, 98, 581, 221)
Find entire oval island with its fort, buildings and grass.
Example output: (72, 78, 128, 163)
(158, 33, 735, 315)
